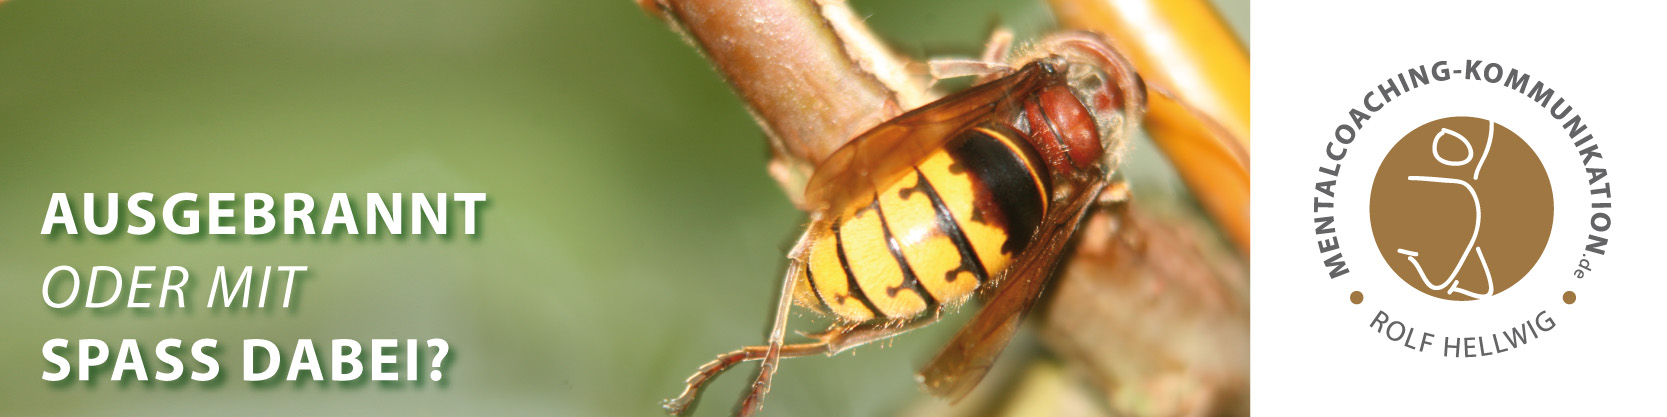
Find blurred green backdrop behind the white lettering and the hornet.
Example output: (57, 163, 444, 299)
(0, 0, 1249, 415)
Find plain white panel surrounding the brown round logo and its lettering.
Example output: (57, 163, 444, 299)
(1250, 2, 1667, 415)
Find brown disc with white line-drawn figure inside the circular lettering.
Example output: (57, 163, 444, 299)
(1370, 117, 1552, 300)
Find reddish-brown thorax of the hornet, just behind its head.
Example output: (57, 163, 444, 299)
(1025, 85, 1110, 172)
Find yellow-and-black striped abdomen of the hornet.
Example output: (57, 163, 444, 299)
(793, 128, 1049, 322)
